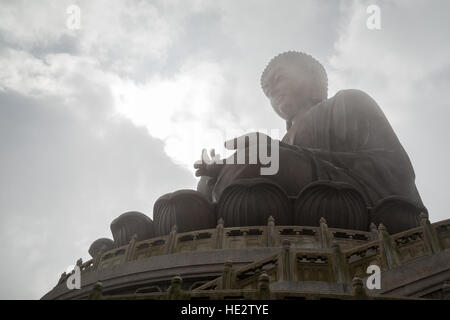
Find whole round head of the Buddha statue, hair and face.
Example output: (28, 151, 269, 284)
(261, 51, 328, 121)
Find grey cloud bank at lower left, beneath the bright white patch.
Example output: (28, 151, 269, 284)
(0, 88, 195, 298)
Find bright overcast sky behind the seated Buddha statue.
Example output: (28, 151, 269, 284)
(0, 0, 450, 299)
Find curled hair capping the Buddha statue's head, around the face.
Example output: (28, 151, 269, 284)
(261, 51, 328, 102)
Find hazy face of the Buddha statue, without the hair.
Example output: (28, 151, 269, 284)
(266, 66, 311, 120)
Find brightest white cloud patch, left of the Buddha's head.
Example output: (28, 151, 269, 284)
(112, 61, 234, 169)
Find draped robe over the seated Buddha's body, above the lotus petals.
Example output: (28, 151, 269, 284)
(199, 90, 423, 212)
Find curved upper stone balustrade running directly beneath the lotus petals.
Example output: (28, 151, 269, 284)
(91, 218, 373, 269)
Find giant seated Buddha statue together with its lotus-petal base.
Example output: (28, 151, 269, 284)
(93, 52, 426, 256)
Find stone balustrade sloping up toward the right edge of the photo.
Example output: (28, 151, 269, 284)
(189, 217, 450, 291)
